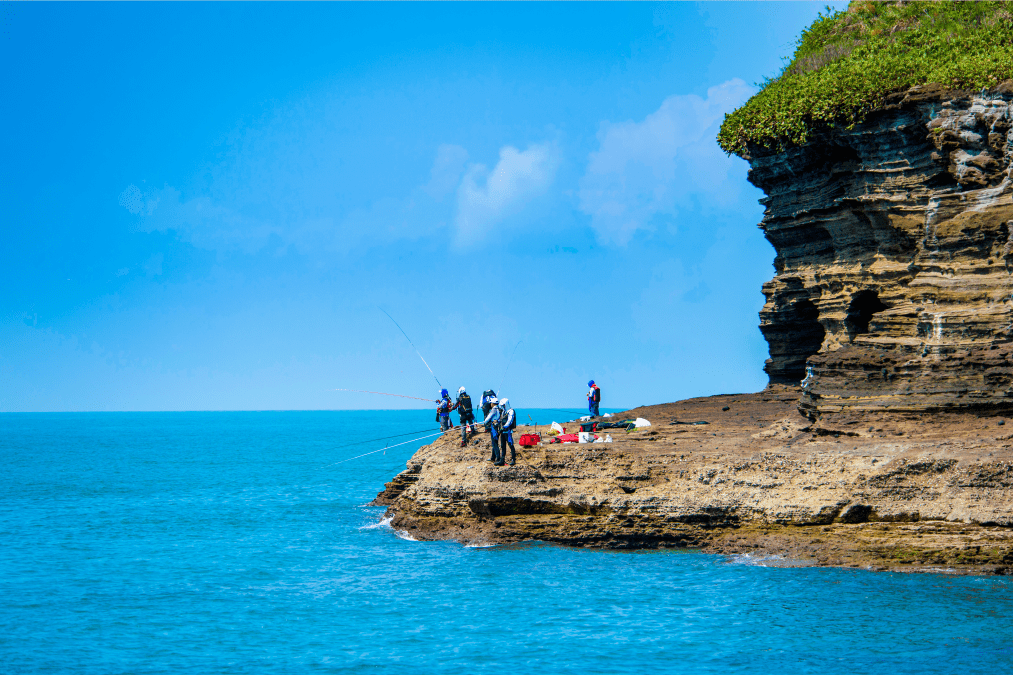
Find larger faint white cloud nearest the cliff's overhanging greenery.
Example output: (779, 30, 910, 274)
(579, 79, 753, 244)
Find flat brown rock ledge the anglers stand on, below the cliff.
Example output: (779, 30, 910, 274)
(376, 385, 1013, 574)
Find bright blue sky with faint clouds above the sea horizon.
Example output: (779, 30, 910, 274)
(0, 2, 846, 410)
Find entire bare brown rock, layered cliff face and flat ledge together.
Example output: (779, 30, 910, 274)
(377, 83, 1013, 574)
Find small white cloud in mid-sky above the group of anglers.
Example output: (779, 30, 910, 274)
(455, 143, 559, 245)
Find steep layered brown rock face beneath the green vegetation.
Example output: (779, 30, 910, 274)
(749, 82, 1013, 417)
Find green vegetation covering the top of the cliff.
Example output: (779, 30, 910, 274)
(717, 1, 1013, 154)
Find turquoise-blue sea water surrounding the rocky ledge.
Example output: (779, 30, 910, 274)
(0, 410, 1013, 675)
